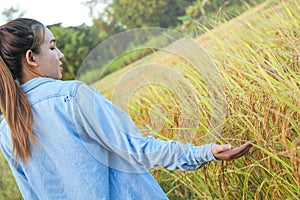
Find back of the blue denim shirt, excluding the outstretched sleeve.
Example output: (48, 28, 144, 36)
(0, 78, 166, 199)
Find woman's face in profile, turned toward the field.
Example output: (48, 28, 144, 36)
(34, 28, 64, 79)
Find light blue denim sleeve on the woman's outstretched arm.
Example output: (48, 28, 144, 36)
(74, 83, 215, 173)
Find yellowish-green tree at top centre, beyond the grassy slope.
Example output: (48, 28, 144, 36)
(112, 0, 194, 29)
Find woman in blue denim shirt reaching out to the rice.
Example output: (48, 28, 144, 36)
(0, 18, 251, 200)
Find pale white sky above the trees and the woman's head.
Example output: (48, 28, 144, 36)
(0, 0, 104, 26)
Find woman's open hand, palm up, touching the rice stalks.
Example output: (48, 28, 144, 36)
(211, 141, 252, 160)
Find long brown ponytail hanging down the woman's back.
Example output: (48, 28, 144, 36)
(0, 56, 36, 162)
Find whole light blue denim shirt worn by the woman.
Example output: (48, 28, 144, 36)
(0, 78, 215, 200)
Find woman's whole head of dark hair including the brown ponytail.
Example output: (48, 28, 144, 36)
(0, 18, 45, 161)
